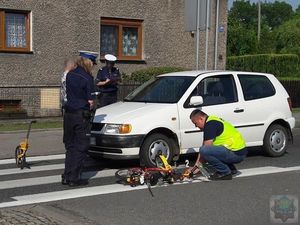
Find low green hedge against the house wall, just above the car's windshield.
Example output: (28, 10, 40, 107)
(126, 67, 186, 82)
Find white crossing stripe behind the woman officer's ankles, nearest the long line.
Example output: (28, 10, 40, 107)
(0, 169, 117, 190)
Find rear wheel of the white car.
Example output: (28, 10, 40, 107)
(263, 124, 288, 157)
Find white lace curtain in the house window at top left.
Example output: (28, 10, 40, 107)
(5, 13, 26, 48)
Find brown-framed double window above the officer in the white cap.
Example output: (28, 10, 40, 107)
(100, 18, 143, 60)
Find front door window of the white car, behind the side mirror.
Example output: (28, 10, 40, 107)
(184, 75, 237, 108)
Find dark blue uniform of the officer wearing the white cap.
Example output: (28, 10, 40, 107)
(95, 66, 121, 107)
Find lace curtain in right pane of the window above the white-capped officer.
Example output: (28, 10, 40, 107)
(123, 27, 138, 56)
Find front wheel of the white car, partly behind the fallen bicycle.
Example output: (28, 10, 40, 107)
(140, 133, 175, 167)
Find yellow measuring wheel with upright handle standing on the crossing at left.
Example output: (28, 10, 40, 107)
(15, 120, 36, 169)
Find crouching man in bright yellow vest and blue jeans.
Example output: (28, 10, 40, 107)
(190, 109, 247, 180)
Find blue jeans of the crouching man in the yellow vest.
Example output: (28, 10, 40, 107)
(199, 145, 248, 174)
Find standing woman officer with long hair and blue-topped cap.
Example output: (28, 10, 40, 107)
(62, 51, 98, 187)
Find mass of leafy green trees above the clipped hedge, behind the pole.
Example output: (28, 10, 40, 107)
(227, 0, 300, 56)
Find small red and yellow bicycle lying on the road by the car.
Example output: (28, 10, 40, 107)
(115, 154, 213, 196)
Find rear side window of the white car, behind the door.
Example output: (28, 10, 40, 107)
(238, 74, 275, 101)
